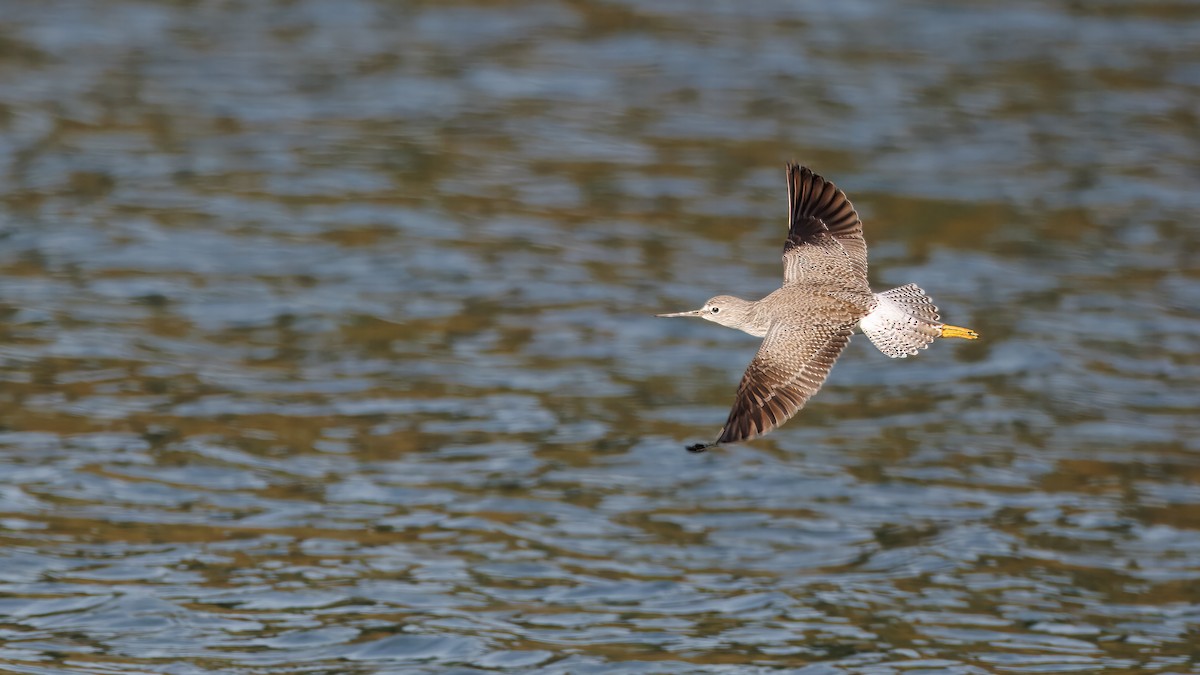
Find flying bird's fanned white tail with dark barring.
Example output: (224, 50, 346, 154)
(858, 283, 942, 359)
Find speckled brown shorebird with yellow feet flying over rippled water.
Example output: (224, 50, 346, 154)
(656, 163, 979, 453)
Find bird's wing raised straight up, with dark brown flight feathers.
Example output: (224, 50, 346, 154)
(784, 163, 866, 287)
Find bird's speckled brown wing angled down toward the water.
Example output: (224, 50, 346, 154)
(710, 323, 853, 449)
